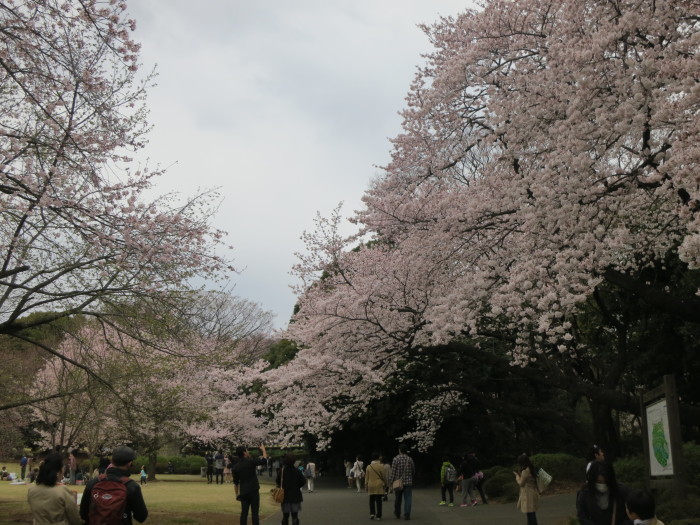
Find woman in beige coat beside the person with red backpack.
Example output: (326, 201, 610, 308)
(27, 453, 83, 525)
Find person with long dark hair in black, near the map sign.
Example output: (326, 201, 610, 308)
(576, 461, 632, 525)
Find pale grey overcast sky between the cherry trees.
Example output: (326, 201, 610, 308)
(129, 0, 469, 328)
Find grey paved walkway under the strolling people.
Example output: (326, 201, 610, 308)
(263, 478, 576, 525)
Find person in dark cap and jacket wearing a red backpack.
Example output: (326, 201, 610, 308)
(80, 447, 148, 525)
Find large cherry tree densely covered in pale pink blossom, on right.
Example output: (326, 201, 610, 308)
(256, 0, 700, 447)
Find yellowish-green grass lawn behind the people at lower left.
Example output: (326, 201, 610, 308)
(0, 474, 279, 525)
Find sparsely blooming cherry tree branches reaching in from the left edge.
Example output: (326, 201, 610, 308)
(0, 0, 233, 406)
